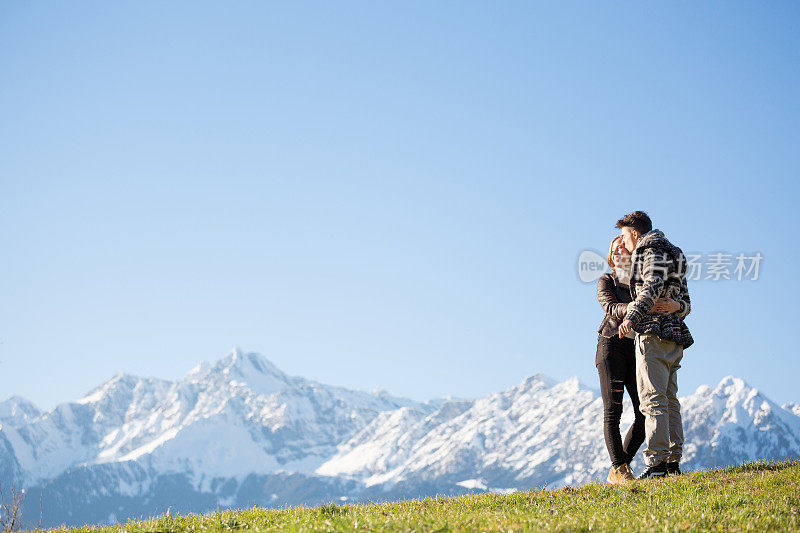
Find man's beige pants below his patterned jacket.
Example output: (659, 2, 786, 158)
(634, 333, 683, 466)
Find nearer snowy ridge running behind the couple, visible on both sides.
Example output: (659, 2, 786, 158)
(317, 376, 800, 487)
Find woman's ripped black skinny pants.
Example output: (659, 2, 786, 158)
(595, 335, 644, 466)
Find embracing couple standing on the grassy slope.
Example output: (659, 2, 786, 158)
(595, 211, 694, 483)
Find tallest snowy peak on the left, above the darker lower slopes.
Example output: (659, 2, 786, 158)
(6, 348, 432, 488)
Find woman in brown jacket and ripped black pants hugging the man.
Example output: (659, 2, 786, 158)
(595, 235, 680, 483)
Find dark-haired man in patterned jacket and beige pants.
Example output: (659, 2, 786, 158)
(617, 211, 694, 479)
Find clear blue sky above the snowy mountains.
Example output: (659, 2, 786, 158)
(0, 1, 800, 408)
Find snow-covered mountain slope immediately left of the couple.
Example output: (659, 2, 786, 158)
(316, 375, 602, 486)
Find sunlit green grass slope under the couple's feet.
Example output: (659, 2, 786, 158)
(59, 461, 800, 532)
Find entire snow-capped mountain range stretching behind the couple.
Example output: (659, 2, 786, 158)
(0, 349, 800, 526)
